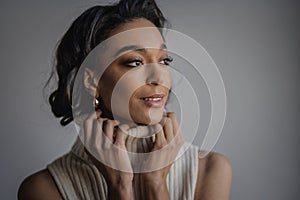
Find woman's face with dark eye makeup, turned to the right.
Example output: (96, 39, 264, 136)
(98, 19, 171, 125)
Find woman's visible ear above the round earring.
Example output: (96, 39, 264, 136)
(83, 68, 99, 97)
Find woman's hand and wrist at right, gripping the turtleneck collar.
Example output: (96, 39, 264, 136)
(141, 112, 184, 199)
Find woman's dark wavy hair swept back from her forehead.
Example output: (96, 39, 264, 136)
(45, 0, 169, 126)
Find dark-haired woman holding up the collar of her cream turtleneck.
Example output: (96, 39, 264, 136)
(18, 0, 231, 200)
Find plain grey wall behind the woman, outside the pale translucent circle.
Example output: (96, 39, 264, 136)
(0, 0, 300, 200)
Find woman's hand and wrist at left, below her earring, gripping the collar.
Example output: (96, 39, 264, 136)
(84, 110, 133, 199)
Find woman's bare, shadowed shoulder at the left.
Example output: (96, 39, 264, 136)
(18, 169, 62, 200)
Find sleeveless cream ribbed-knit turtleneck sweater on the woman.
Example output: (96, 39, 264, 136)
(47, 127, 199, 200)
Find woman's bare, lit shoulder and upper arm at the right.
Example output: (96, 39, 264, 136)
(195, 152, 232, 200)
